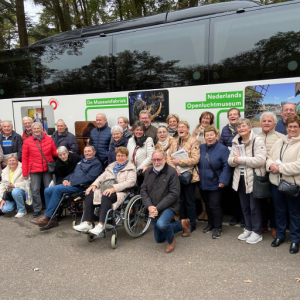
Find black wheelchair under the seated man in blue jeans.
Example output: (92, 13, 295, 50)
(40, 183, 90, 231)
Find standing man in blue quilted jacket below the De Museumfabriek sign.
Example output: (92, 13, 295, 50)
(89, 113, 111, 167)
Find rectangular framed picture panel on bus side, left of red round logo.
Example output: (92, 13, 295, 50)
(12, 97, 42, 135)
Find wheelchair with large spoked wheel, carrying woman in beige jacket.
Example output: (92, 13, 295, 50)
(82, 185, 151, 249)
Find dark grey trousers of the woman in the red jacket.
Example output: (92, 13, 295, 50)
(30, 172, 52, 212)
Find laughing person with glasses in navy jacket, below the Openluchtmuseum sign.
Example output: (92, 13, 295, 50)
(219, 107, 245, 227)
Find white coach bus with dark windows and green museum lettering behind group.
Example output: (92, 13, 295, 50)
(0, 0, 300, 150)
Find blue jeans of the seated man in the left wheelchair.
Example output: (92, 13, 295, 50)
(44, 184, 84, 218)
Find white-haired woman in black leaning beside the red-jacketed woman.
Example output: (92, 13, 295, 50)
(55, 146, 81, 185)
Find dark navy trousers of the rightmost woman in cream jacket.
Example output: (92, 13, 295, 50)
(272, 184, 300, 243)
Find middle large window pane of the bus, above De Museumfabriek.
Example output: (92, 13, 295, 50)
(113, 20, 208, 91)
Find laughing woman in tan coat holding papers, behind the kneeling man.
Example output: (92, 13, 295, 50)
(167, 121, 200, 236)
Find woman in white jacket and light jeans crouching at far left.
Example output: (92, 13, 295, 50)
(0, 154, 27, 218)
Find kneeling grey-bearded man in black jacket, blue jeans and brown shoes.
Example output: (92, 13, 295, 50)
(141, 150, 190, 253)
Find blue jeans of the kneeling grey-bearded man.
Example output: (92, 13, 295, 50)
(151, 208, 182, 244)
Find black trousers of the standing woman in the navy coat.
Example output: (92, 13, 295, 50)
(201, 190, 223, 229)
